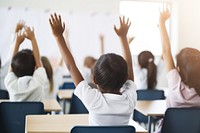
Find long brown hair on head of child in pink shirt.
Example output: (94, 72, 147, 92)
(176, 48, 200, 96)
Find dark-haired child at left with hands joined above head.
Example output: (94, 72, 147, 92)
(5, 22, 47, 101)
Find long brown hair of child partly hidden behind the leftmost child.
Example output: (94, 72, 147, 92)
(41, 56, 53, 93)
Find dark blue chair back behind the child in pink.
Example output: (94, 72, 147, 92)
(161, 108, 200, 133)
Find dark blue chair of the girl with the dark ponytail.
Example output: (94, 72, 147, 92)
(133, 89, 165, 129)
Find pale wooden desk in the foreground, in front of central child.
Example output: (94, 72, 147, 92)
(25, 114, 147, 133)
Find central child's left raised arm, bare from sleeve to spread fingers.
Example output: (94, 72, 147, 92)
(49, 13, 83, 86)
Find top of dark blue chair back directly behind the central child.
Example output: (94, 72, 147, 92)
(70, 125, 135, 133)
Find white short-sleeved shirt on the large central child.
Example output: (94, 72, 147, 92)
(74, 80, 137, 126)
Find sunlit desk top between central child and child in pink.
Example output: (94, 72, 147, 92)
(135, 100, 167, 116)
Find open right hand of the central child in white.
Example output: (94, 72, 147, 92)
(114, 17, 131, 37)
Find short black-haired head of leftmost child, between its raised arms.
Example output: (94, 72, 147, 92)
(11, 49, 35, 77)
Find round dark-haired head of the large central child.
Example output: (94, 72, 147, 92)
(93, 53, 128, 93)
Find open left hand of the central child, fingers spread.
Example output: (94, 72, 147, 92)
(49, 13, 65, 37)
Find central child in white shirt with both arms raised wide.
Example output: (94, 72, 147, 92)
(49, 14, 137, 125)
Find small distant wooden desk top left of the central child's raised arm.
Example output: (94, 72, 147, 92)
(57, 89, 74, 100)
